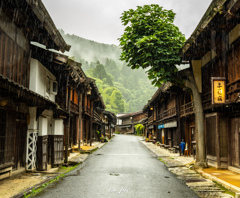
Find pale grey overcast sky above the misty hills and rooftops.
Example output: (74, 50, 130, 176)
(42, 0, 211, 45)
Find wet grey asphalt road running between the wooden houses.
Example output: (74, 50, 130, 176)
(37, 135, 198, 198)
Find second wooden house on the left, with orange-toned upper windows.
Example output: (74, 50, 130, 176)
(32, 46, 88, 166)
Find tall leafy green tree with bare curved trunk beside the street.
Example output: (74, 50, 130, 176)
(119, 4, 207, 166)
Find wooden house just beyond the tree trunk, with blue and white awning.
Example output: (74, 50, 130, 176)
(143, 83, 182, 149)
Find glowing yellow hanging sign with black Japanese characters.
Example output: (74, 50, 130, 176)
(211, 77, 226, 104)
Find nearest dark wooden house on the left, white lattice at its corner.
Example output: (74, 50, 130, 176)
(0, 0, 70, 176)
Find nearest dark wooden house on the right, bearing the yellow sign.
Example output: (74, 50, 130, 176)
(182, 0, 240, 170)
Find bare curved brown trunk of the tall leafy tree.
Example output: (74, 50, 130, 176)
(184, 74, 207, 168)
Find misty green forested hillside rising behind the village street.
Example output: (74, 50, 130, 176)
(60, 30, 156, 113)
